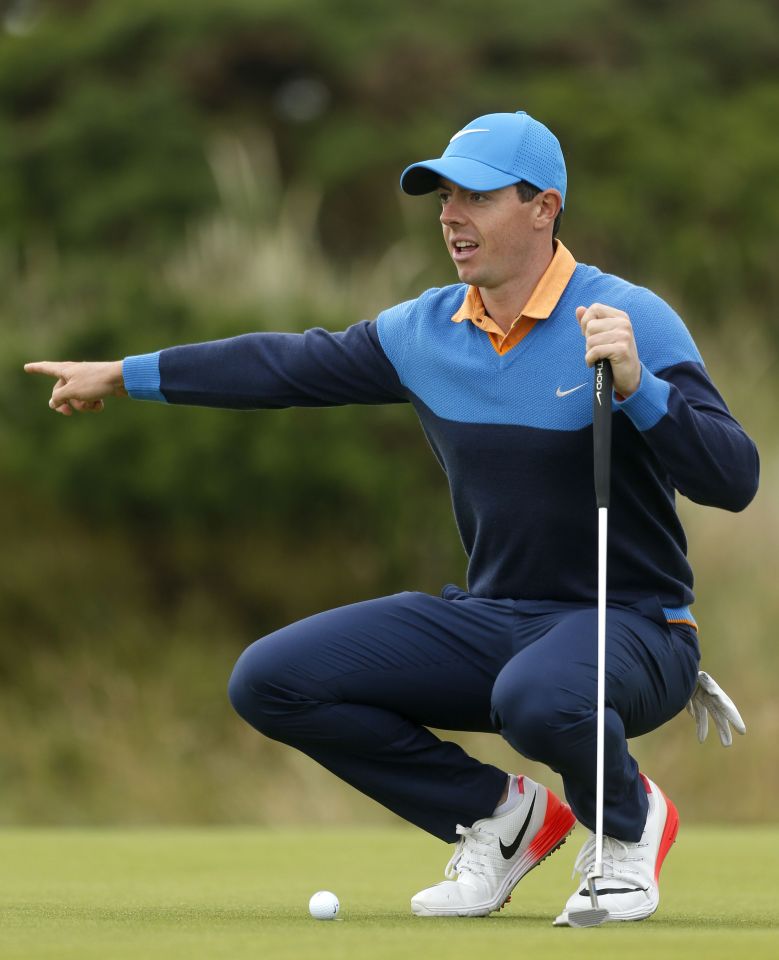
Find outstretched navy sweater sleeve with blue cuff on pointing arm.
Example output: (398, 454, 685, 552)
(122, 321, 407, 410)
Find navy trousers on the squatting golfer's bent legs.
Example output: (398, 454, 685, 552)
(229, 586, 700, 842)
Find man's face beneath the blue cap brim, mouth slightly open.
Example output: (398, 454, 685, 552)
(438, 179, 538, 290)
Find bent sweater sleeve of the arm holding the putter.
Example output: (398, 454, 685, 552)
(615, 298, 760, 511)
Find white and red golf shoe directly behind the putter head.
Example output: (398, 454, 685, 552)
(554, 774, 679, 927)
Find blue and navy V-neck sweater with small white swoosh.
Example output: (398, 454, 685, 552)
(123, 255, 759, 620)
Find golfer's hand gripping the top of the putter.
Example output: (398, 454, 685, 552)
(576, 303, 641, 399)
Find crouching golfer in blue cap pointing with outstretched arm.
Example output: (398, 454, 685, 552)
(26, 112, 758, 926)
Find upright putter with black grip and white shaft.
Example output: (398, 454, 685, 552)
(568, 360, 613, 927)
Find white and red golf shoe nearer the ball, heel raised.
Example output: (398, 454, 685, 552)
(411, 777, 576, 917)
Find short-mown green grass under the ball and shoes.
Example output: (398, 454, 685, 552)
(0, 825, 779, 960)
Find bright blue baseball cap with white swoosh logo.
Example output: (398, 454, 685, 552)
(400, 110, 568, 204)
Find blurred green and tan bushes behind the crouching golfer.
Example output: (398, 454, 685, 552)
(0, 0, 779, 824)
